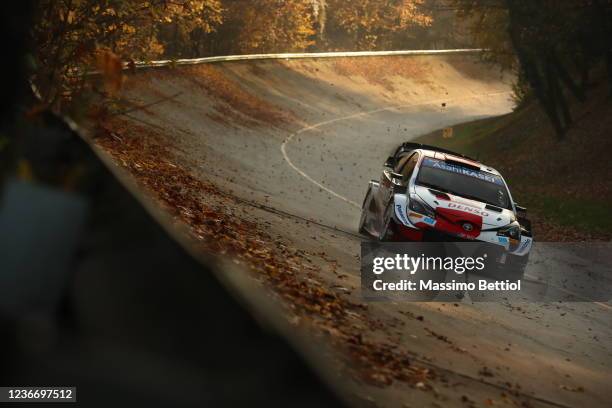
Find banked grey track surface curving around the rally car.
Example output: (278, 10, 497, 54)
(120, 56, 612, 407)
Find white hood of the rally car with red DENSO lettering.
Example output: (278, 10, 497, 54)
(414, 186, 516, 229)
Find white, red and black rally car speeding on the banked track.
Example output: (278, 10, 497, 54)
(359, 143, 533, 278)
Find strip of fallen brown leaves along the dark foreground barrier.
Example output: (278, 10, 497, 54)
(97, 117, 435, 390)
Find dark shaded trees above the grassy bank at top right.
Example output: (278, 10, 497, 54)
(451, 0, 612, 139)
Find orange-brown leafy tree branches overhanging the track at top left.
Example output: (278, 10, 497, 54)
(32, 0, 221, 105)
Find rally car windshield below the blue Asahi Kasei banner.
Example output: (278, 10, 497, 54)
(416, 157, 511, 209)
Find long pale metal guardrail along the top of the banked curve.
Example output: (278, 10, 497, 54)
(126, 48, 484, 69)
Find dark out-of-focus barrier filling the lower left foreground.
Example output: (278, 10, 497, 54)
(0, 2, 341, 407)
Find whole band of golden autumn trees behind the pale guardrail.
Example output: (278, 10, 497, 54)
(32, 0, 440, 108)
